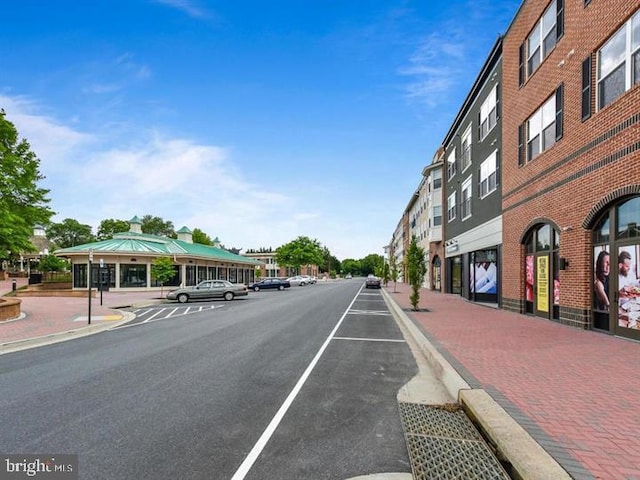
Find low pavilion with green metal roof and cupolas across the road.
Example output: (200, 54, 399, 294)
(54, 216, 261, 291)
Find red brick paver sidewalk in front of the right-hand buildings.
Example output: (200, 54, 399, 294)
(387, 283, 640, 480)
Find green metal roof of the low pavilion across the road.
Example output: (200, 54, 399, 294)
(54, 232, 260, 265)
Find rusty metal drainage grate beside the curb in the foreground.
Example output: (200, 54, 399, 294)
(399, 403, 510, 480)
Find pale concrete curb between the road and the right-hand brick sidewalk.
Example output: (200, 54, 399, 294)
(382, 289, 571, 480)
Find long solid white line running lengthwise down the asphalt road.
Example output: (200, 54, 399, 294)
(231, 287, 363, 480)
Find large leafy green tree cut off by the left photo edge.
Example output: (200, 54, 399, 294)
(0, 109, 54, 258)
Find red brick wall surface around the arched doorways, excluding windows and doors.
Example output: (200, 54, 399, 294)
(502, 0, 640, 336)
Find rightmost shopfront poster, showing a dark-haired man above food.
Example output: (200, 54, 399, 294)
(616, 245, 640, 330)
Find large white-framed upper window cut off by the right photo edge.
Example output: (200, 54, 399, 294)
(597, 12, 640, 108)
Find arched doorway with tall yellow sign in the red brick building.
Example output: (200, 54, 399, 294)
(524, 223, 560, 319)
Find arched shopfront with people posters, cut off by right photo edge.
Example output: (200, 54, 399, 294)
(592, 196, 640, 340)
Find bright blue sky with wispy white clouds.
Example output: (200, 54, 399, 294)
(0, 0, 520, 260)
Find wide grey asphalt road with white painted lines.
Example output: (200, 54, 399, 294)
(0, 279, 417, 480)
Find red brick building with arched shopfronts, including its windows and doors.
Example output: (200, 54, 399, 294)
(502, 0, 640, 339)
